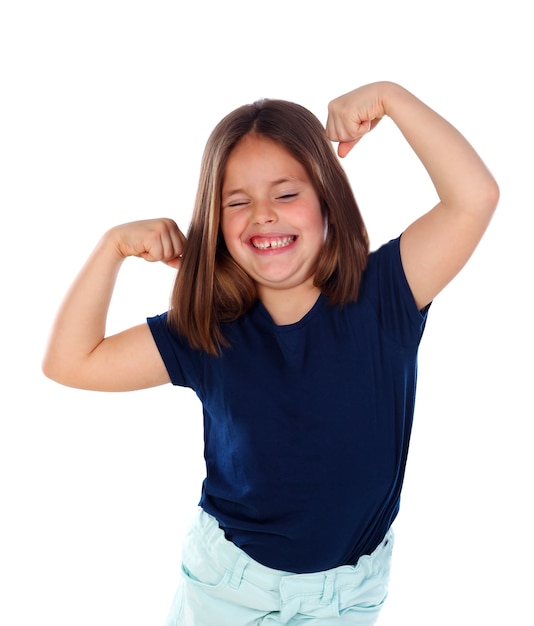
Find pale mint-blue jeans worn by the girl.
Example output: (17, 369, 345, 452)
(166, 509, 393, 626)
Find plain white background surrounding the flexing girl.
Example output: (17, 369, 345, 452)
(0, 0, 534, 626)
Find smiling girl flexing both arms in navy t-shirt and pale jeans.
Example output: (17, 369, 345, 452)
(43, 82, 499, 626)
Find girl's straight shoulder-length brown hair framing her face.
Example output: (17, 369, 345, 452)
(168, 99, 369, 354)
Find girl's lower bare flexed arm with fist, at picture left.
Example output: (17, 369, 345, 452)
(42, 218, 185, 391)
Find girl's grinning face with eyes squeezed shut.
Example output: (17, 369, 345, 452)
(221, 134, 325, 298)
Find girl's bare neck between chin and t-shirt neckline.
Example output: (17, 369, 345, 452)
(258, 284, 321, 326)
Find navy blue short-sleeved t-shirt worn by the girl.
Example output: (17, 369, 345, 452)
(148, 238, 432, 573)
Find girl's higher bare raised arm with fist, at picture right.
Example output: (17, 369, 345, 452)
(326, 82, 499, 308)
